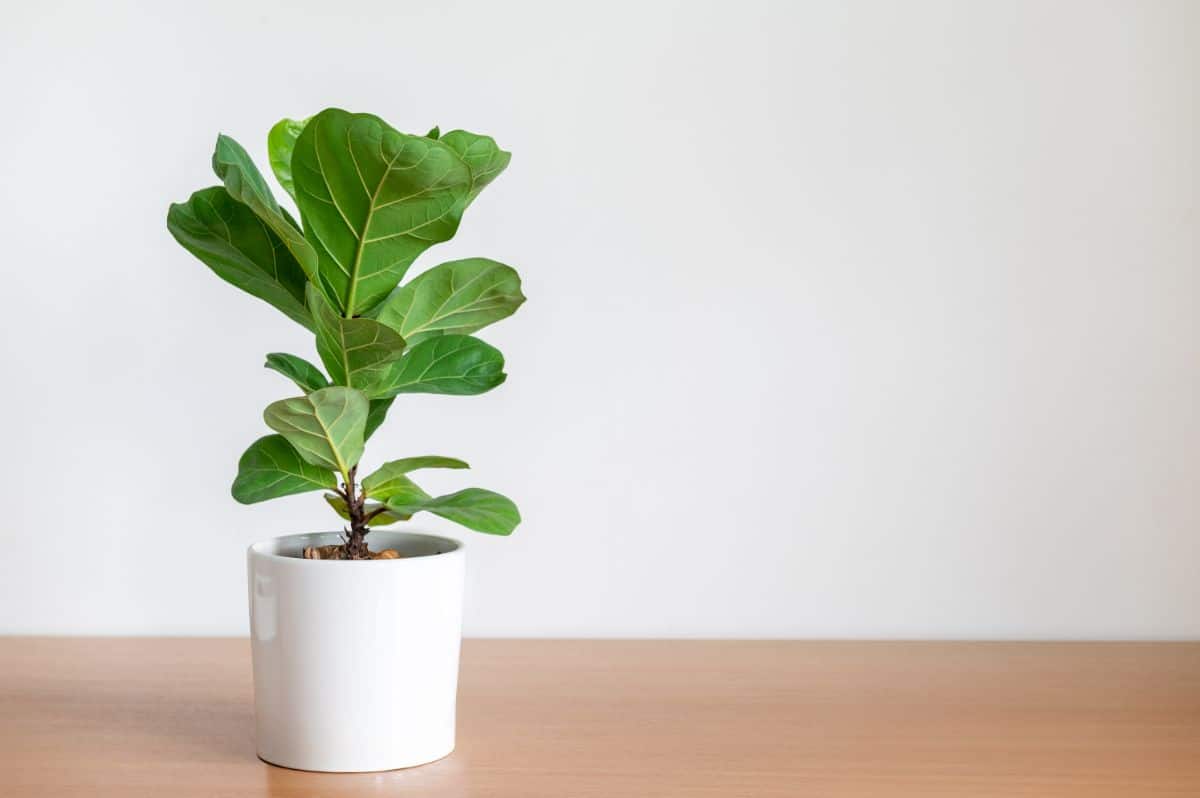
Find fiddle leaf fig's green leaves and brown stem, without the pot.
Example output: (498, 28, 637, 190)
(167, 108, 524, 559)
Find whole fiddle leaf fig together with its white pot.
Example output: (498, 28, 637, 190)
(167, 108, 524, 772)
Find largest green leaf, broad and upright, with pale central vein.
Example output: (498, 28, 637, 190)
(292, 108, 511, 318)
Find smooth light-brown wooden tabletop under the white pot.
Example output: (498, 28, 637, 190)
(0, 637, 1200, 798)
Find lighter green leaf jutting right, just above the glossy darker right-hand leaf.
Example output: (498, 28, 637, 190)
(376, 258, 526, 346)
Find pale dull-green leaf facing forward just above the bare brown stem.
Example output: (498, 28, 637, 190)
(263, 385, 367, 475)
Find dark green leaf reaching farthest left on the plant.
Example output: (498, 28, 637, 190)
(167, 186, 313, 330)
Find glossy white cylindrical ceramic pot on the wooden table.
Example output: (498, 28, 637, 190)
(247, 530, 464, 772)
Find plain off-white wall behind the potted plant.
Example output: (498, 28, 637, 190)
(0, 0, 1200, 637)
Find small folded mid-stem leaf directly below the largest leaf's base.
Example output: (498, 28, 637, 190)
(308, 283, 404, 398)
